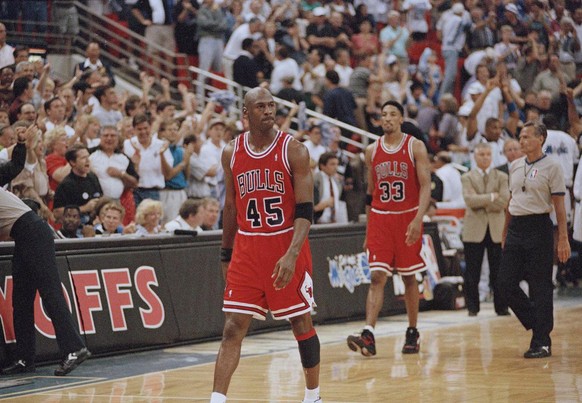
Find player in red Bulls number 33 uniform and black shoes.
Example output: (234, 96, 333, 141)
(348, 101, 430, 357)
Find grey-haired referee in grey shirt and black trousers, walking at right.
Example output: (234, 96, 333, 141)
(499, 122, 570, 358)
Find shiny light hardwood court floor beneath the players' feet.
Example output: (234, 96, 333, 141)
(1, 297, 582, 403)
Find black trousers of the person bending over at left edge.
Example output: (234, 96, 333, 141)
(10, 211, 85, 364)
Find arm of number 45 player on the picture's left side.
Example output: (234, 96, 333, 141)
(220, 141, 238, 280)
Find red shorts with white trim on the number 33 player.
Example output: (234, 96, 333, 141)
(366, 210, 426, 276)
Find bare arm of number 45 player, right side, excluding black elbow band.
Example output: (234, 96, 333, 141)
(272, 140, 313, 290)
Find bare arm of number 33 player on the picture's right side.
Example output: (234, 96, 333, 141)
(406, 139, 430, 245)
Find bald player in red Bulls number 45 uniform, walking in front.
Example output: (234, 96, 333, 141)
(210, 88, 321, 403)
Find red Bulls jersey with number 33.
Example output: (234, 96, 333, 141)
(372, 133, 420, 213)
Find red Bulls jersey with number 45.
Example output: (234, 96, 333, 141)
(230, 131, 295, 233)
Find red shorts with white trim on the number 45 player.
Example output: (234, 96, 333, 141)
(222, 230, 315, 320)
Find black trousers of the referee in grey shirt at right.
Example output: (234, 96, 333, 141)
(499, 214, 554, 348)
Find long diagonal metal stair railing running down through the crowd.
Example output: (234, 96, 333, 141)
(4, 1, 378, 154)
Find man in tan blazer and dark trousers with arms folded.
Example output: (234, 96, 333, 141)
(461, 143, 509, 316)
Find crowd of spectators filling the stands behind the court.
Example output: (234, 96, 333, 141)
(0, 0, 582, 280)
